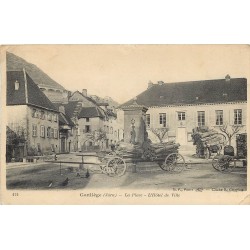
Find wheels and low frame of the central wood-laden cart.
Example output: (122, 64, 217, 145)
(96, 146, 185, 177)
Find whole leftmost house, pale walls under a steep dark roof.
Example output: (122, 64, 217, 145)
(6, 70, 59, 160)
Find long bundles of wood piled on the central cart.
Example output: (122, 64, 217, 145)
(117, 141, 180, 161)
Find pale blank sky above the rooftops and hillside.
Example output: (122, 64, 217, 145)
(4, 45, 250, 104)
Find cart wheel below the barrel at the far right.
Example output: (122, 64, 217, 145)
(212, 155, 235, 173)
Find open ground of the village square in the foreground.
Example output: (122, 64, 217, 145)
(7, 156, 247, 190)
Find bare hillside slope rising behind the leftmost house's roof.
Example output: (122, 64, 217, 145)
(6, 52, 65, 90)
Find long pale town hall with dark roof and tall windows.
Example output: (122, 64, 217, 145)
(118, 75, 247, 146)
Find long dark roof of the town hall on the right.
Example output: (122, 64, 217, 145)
(120, 78, 247, 108)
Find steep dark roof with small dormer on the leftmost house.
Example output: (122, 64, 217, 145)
(7, 71, 57, 112)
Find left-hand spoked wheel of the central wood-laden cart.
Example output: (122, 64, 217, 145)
(105, 156, 127, 177)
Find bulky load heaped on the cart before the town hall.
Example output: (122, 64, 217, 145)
(192, 127, 225, 156)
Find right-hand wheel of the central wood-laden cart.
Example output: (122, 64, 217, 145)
(160, 153, 185, 173)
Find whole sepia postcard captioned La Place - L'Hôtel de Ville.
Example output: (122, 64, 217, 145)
(0, 45, 250, 204)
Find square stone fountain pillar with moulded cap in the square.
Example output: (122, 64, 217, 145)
(122, 101, 148, 144)
